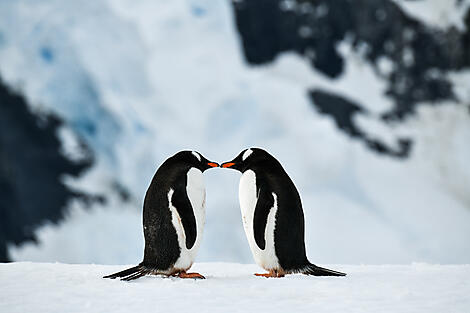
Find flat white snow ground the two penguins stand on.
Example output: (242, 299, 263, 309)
(0, 262, 470, 313)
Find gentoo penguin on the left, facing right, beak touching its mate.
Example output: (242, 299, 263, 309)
(104, 151, 219, 281)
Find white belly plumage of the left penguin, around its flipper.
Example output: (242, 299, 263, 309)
(168, 168, 206, 270)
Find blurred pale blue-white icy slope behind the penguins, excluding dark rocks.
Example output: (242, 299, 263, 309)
(0, 0, 470, 264)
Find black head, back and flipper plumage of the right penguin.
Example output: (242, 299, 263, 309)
(225, 148, 310, 271)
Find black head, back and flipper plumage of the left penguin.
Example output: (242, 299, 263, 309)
(142, 151, 210, 270)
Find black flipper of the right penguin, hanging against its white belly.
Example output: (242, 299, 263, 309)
(253, 189, 274, 250)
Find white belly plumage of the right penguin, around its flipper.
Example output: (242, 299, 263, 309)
(238, 170, 279, 270)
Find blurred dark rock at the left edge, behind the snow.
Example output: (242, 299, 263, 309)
(0, 81, 94, 262)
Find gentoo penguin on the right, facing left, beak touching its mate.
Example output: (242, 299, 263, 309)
(221, 148, 346, 277)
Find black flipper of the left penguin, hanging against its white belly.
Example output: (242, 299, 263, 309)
(171, 185, 197, 249)
